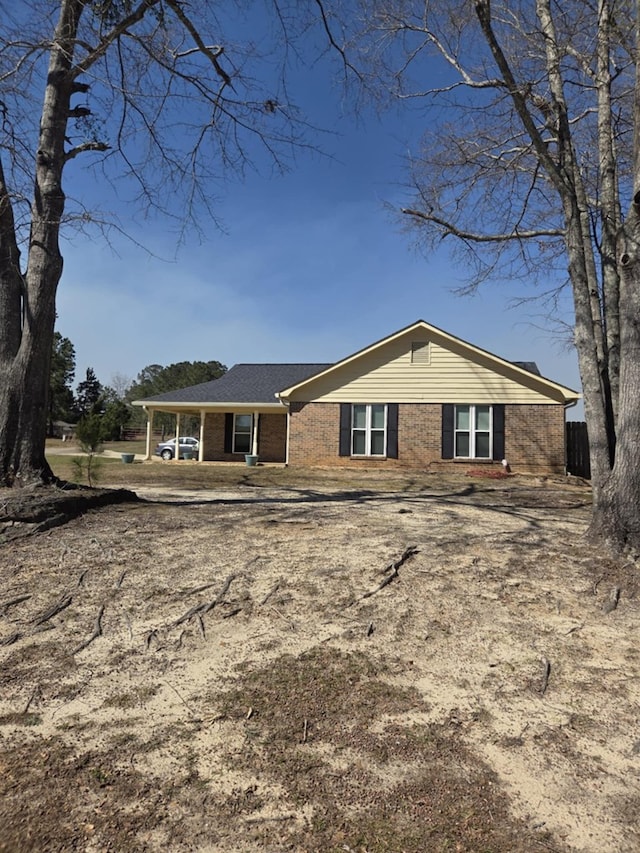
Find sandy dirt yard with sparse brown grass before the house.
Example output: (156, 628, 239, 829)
(0, 476, 640, 853)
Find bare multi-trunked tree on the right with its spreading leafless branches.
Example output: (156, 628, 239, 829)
(328, 0, 640, 552)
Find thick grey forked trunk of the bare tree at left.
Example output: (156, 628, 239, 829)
(0, 0, 84, 485)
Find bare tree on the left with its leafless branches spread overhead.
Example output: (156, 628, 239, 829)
(0, 0, 318, 485)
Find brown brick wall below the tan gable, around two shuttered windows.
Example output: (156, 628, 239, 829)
(289, 403, 565, 473)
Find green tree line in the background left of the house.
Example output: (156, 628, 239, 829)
(48, 332, 227, 443)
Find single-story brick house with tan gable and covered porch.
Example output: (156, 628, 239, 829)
(134, 320, 580, 473)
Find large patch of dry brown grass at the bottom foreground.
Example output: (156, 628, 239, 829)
(209, 647, 563, 853)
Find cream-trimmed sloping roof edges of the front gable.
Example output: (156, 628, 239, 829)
(278, 320, 581, 402)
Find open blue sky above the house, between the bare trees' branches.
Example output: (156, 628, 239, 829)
(51, 13, 580, 410)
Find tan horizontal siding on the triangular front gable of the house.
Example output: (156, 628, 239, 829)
(290, 329, 564, 404)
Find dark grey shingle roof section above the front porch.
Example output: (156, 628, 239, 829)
(136, 364, 331, 403)
